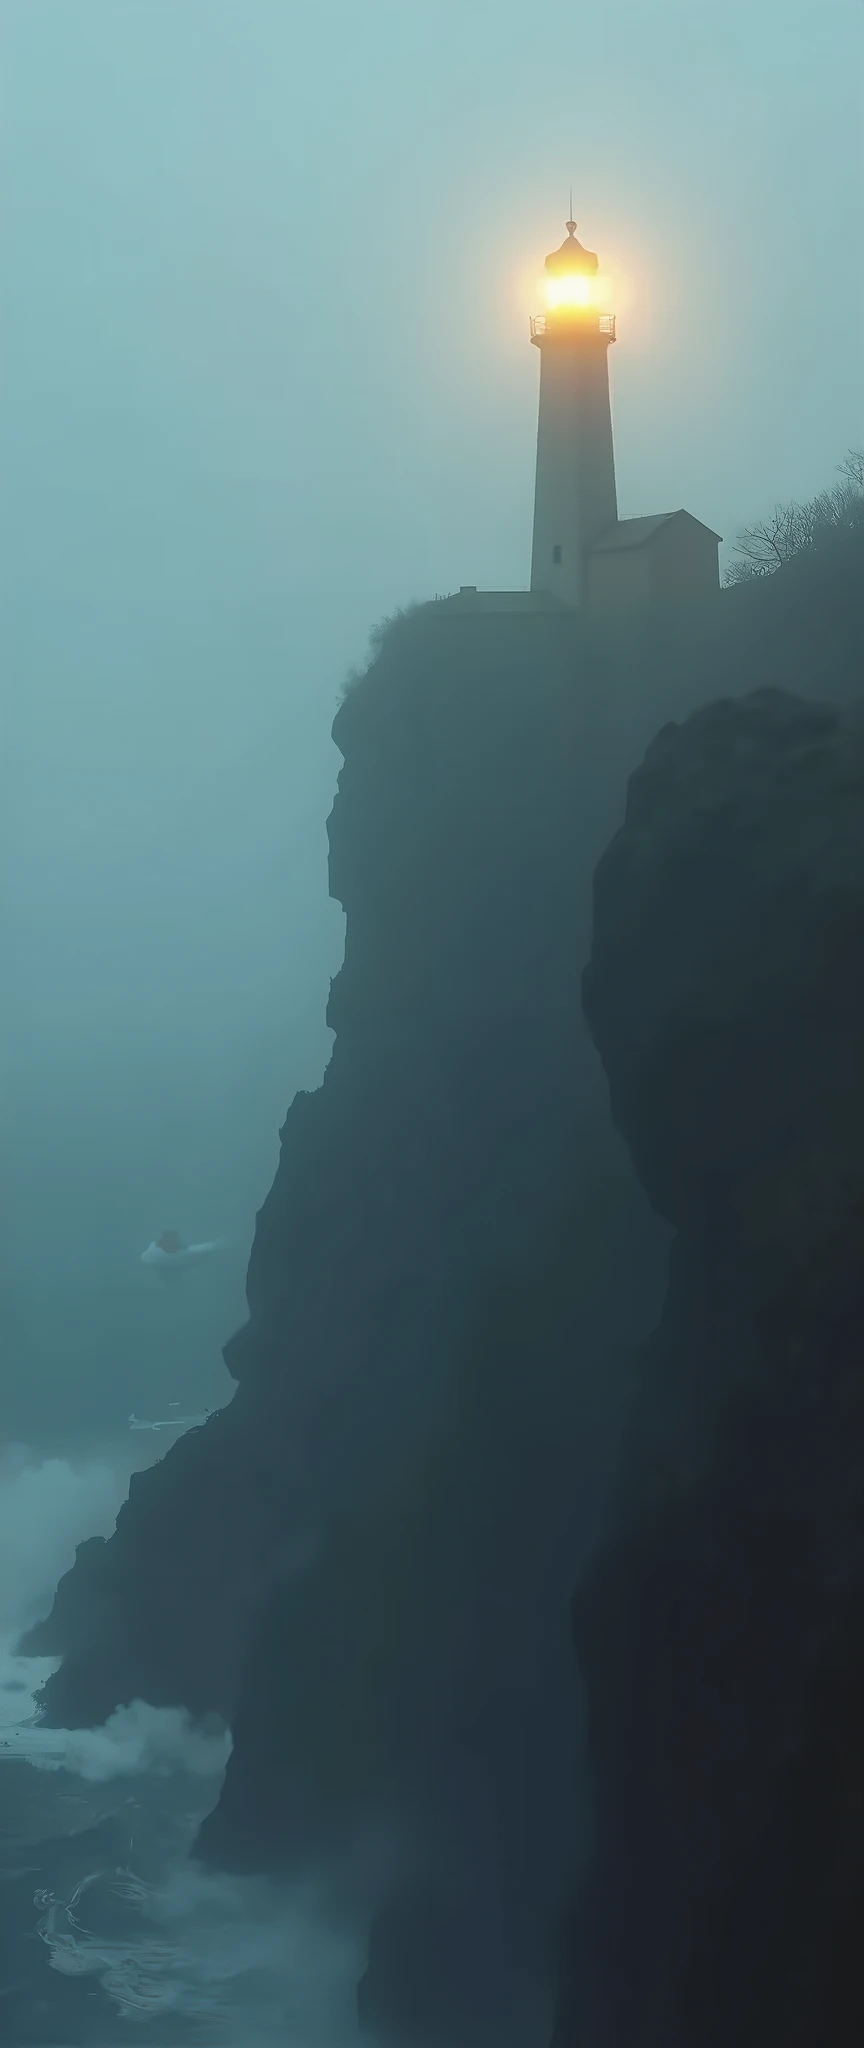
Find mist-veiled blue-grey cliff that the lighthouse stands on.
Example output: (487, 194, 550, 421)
(29, 547, 862, 2048)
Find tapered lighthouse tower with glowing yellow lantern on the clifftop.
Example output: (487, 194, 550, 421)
(530, 221, 618, 604)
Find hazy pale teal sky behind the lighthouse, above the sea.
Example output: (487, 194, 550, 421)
(0, 0, 864, 1327)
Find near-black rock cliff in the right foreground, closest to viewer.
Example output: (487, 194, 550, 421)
(557, 692, 864, 2048)
